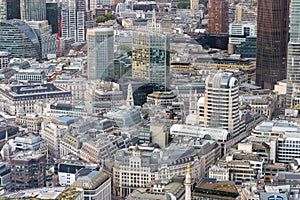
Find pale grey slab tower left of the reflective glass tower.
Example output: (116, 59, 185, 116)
(87, 28, 114, 80)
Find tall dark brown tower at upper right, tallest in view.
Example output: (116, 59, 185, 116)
(256, 0, 289, 89)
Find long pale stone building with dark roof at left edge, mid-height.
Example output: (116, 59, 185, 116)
(0, 83, 71, 115)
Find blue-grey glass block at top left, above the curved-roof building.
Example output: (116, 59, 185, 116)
(20, 0, 46, 21)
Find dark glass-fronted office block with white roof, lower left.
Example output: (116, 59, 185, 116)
(10, 151, 46, 191)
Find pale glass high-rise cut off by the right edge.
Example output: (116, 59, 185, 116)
(286, 0, 300, 107)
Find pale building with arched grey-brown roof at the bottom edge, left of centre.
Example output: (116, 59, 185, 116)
(72, 168, 112, 200)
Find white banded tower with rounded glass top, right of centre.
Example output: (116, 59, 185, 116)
(198, 72, 242, 137)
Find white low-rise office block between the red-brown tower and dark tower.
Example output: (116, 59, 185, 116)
(229, 22, 256, 45)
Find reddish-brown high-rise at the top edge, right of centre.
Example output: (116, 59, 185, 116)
(208, 0, 228, 34)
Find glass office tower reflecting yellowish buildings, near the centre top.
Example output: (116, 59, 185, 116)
(132, 30, 170, 88)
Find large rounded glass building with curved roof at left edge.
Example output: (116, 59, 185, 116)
(0, 19, 41, 59)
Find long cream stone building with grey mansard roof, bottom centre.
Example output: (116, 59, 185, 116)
(113, 141, 221, 197)
